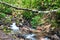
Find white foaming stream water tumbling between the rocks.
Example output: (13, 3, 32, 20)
(10, 22, 50, 40)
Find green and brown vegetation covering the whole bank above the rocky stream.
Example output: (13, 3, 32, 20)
(0, 0, 60, 39)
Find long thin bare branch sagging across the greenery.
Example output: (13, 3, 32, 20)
(0, 1, 60, 13)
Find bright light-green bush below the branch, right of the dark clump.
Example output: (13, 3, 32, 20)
(31, 15, 43, 27)
